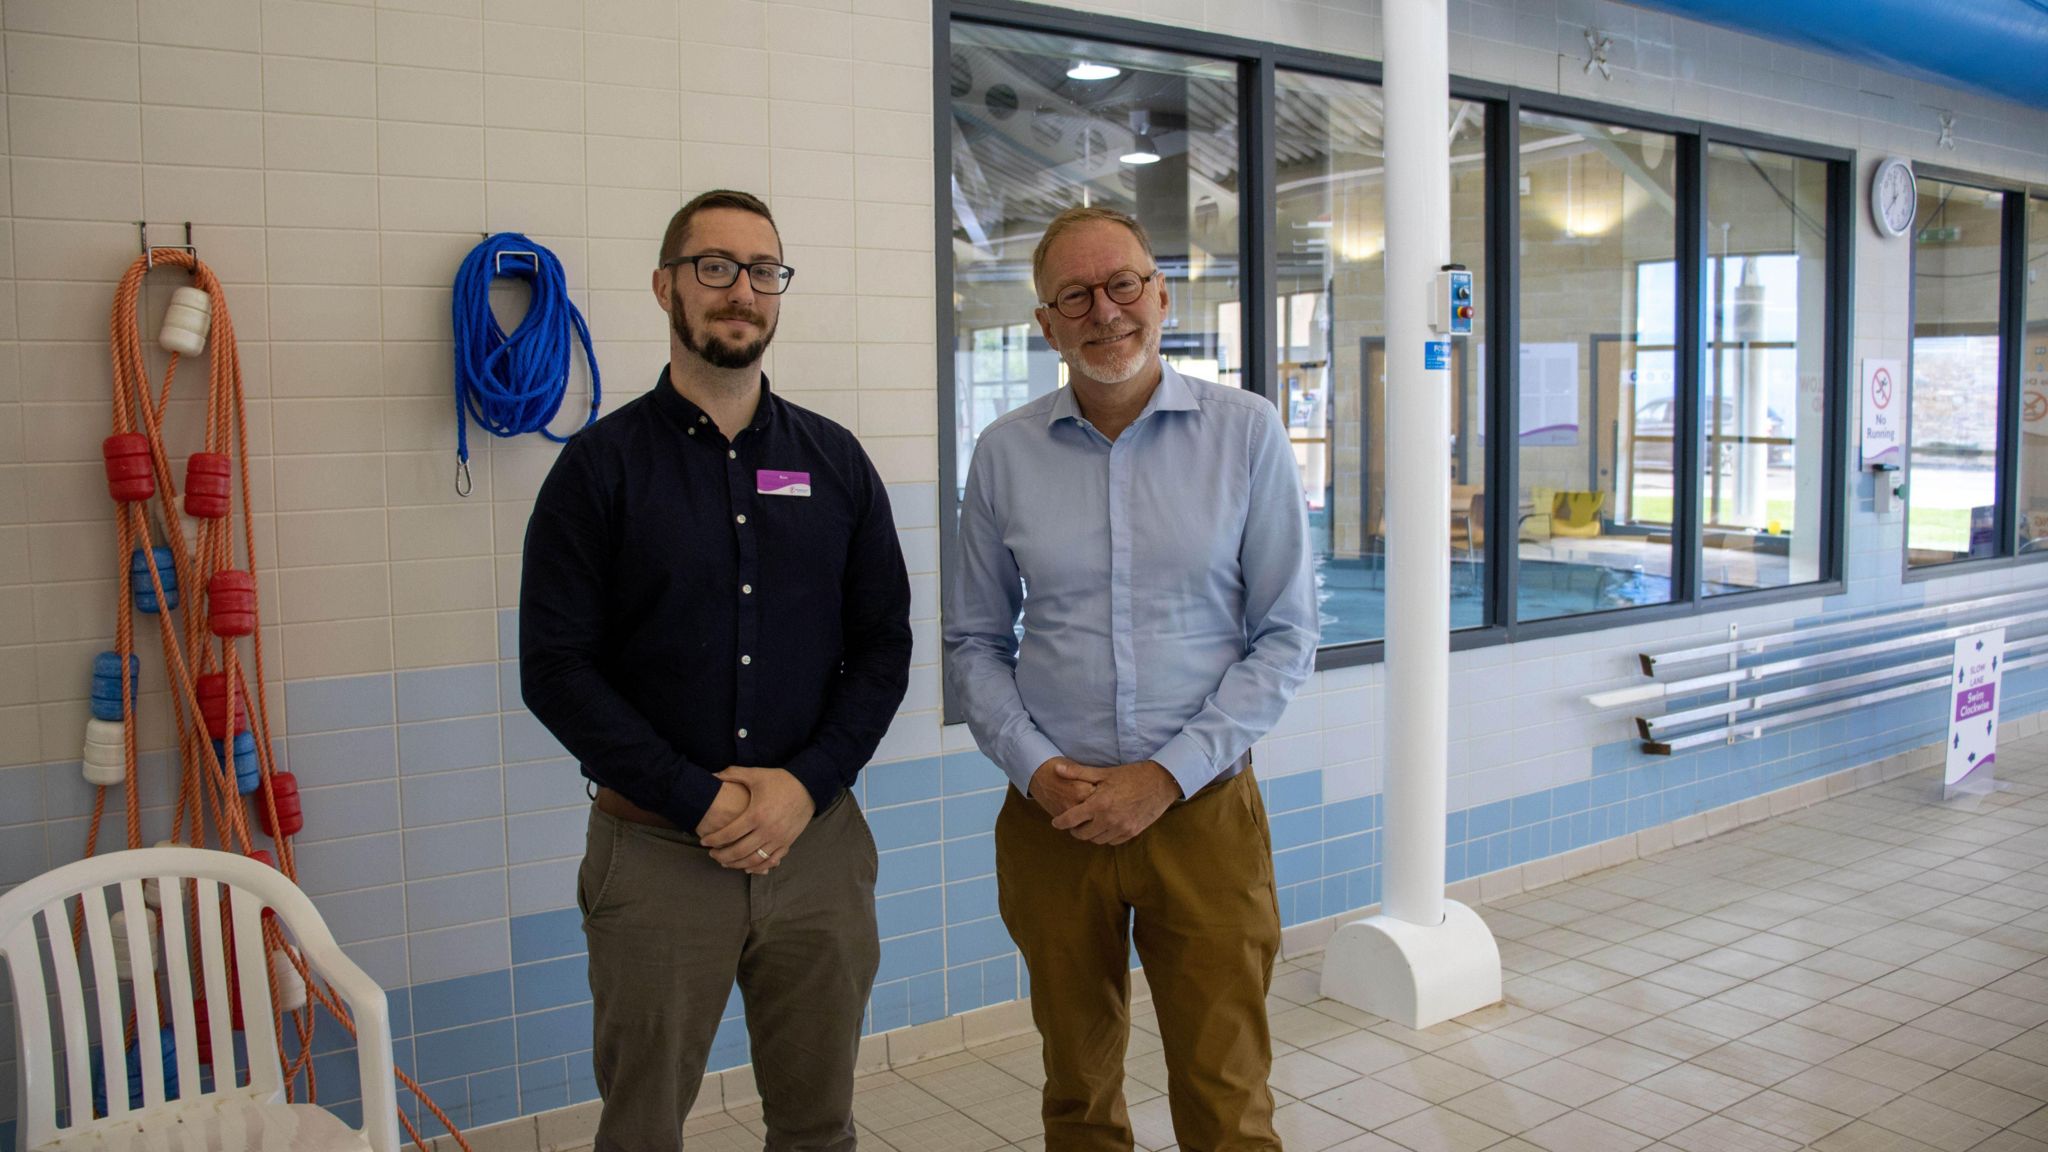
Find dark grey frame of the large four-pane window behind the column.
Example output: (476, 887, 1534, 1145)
(932, 0, 1859, 709)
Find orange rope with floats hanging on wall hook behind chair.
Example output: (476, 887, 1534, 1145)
(107, 248, 469, 1152)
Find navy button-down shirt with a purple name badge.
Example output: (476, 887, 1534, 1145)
(520, 369, 911, 828)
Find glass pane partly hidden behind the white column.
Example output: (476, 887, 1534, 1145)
(1274, 70, 1487, 644)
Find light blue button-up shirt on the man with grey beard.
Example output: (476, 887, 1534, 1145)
(946, 367, 1317, 795)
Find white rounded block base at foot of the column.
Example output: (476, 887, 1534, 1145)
(1323, 900, 1501, 1029)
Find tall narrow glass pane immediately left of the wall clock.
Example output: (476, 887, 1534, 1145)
(1703, 143, 1829, 596)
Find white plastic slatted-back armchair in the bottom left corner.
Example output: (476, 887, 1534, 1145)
(0, 849, 397, 1152)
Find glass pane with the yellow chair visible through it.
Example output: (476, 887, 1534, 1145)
(1516, 113, 1679, 619)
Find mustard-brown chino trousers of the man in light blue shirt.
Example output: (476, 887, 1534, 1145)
(995, 767, 1280, 1152)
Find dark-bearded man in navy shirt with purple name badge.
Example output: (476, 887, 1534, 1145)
(520, 191, 911, 1152)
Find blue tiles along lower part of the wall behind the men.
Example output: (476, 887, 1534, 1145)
(16, 619, 2048, 1134)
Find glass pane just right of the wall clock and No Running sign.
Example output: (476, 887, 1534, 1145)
(1907, 178, 2005, 566)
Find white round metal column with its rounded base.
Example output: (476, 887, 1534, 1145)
(1323, 0, 1501, 1029)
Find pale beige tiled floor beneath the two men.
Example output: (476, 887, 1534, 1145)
(688, 736, 2048, 1152)
